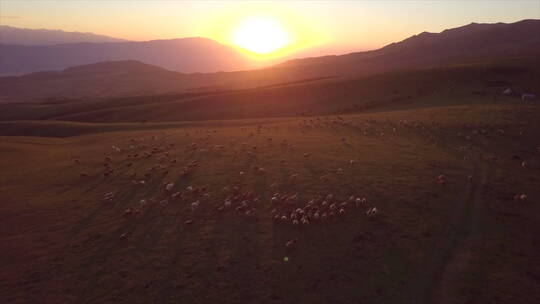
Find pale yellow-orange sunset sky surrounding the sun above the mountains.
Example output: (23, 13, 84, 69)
(0, 0, 540, 55)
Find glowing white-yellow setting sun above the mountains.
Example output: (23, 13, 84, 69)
(232, 17, 291, 54)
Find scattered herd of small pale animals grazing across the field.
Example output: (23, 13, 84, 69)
(71, 116, 528, 247)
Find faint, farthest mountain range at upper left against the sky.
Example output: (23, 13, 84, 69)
(0, 25, 127, 45)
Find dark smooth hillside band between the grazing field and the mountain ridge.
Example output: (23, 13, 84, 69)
(0, 57, 540, 122)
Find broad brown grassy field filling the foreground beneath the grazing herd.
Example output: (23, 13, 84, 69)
(0, 102, 540, 303)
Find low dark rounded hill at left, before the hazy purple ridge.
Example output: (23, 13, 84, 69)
(0, 61, 206, 98)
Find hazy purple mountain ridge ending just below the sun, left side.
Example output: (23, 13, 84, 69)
(0, 38, 250, 75)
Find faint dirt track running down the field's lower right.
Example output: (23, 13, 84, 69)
(405, 164, 489, 304)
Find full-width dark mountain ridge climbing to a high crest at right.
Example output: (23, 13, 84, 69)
(0, 20, 540, 101)
